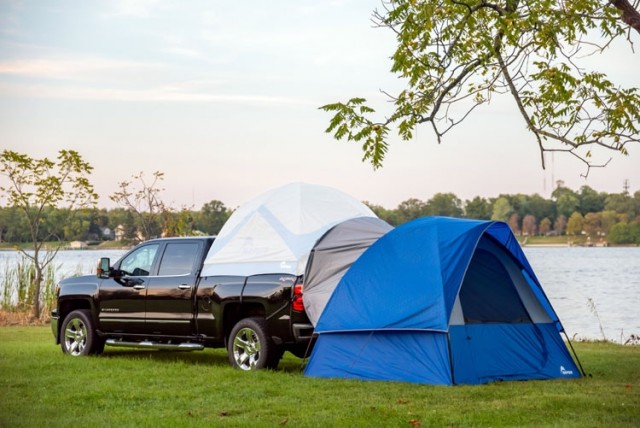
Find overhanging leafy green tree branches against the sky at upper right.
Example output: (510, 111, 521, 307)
(321, 0, 640, 174)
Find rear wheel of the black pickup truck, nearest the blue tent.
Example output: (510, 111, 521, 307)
(227, 317, 282, 371)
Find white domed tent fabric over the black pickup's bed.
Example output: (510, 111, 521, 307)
(202, 183, 376, 276)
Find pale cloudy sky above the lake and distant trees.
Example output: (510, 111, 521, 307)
(0, 0, 640, 209)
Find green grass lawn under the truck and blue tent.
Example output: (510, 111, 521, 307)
(0, 326, 640, 427)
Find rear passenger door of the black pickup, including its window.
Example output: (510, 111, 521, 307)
(145, 240, 203, 336)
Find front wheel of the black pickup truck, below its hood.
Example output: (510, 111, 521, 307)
(60, 309, 99, 357)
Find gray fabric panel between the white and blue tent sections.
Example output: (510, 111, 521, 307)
(304, 217, 393, 326)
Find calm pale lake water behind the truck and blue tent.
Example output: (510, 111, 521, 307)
(0, 247, 640, 342)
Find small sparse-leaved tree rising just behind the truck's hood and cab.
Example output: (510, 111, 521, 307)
(109, 171, 167, 239)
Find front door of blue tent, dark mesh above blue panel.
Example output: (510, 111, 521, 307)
(450, 245, 547, 383)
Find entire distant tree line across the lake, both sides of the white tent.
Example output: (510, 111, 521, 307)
(0, 184, 640, 244)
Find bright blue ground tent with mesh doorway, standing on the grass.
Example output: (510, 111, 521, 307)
(305, 217, 581, 385)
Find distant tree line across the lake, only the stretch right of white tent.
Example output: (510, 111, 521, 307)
(367, 182, 640, 244)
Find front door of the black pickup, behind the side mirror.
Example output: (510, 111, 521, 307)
(98, 243, 160, 334)
